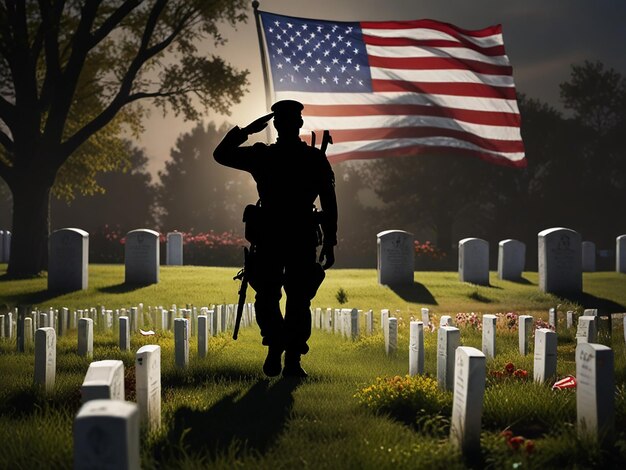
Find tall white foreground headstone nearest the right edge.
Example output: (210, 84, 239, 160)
(576, 343, 615, 442)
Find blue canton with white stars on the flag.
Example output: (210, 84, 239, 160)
(261, 12, 372, 93)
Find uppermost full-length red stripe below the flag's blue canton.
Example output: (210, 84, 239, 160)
(304, 104, 521, 127)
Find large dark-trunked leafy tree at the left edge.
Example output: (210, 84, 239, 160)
(0, 0, 247, 276)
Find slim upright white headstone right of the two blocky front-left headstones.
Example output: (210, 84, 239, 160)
(135, 344, 161, 430)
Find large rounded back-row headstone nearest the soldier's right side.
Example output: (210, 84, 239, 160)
(376, 230, 415, 286)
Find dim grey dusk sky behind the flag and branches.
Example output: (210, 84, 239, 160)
(137, 0, 626, 175)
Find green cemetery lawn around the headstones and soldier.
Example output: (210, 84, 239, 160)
(0, 265, 626, 469)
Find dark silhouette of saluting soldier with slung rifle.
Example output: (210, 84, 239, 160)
(213, 100, 337, 377)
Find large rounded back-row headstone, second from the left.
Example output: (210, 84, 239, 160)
(124, 229, 159, 285)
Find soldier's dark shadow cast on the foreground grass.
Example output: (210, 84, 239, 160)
(160, 379, 300, 459)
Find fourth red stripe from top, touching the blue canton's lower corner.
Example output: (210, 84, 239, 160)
(372, 79, 517, 100)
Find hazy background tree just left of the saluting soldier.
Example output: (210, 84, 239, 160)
(157, 123, 258, 232)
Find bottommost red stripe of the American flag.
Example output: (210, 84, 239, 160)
(328, 145, 527, 168)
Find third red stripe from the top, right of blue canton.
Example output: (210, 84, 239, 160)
(368, 55, 513, 76)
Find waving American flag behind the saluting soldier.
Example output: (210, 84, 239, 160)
(260, 12, 526, 167)
